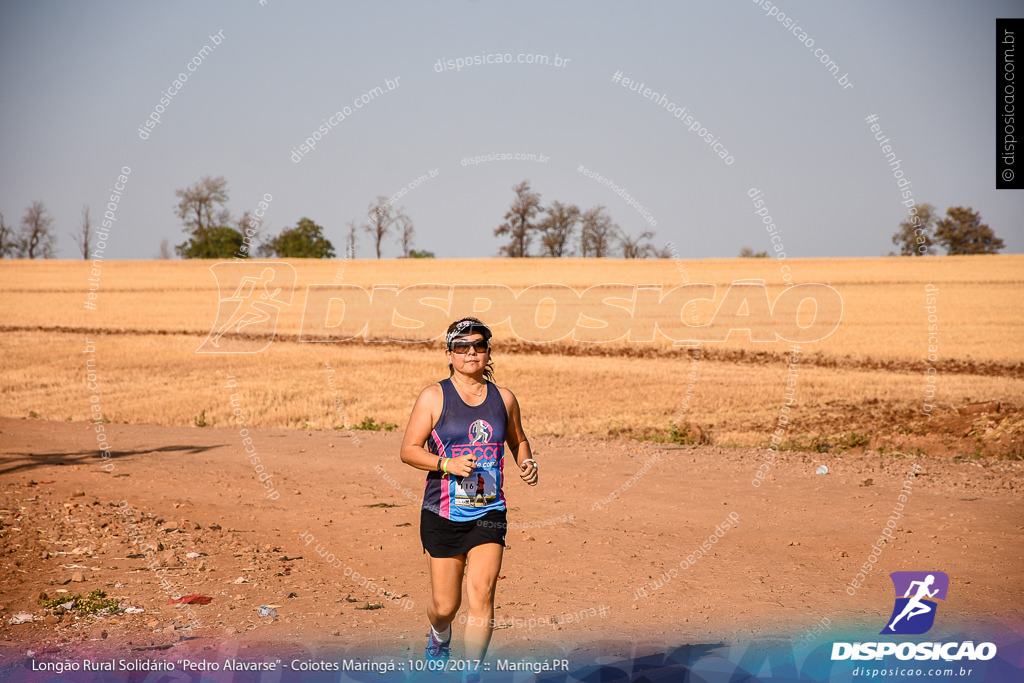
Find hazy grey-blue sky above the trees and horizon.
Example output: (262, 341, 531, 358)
(0, 0, 1024, 259)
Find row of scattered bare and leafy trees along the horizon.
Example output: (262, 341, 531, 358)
(0, 184, 1005, 259)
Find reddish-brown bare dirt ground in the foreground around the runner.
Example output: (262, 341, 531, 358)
(0, 419, 1024, 663)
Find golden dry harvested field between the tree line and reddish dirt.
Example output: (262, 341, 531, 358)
(0, 256, 1024, 458)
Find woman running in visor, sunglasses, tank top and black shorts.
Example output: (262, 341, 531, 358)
(401, 317, 538, 660)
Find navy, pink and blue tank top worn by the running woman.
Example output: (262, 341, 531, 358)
(423, 378, 508, 521)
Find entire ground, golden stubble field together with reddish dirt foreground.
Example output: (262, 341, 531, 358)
(0, 256, 1024, 667)
